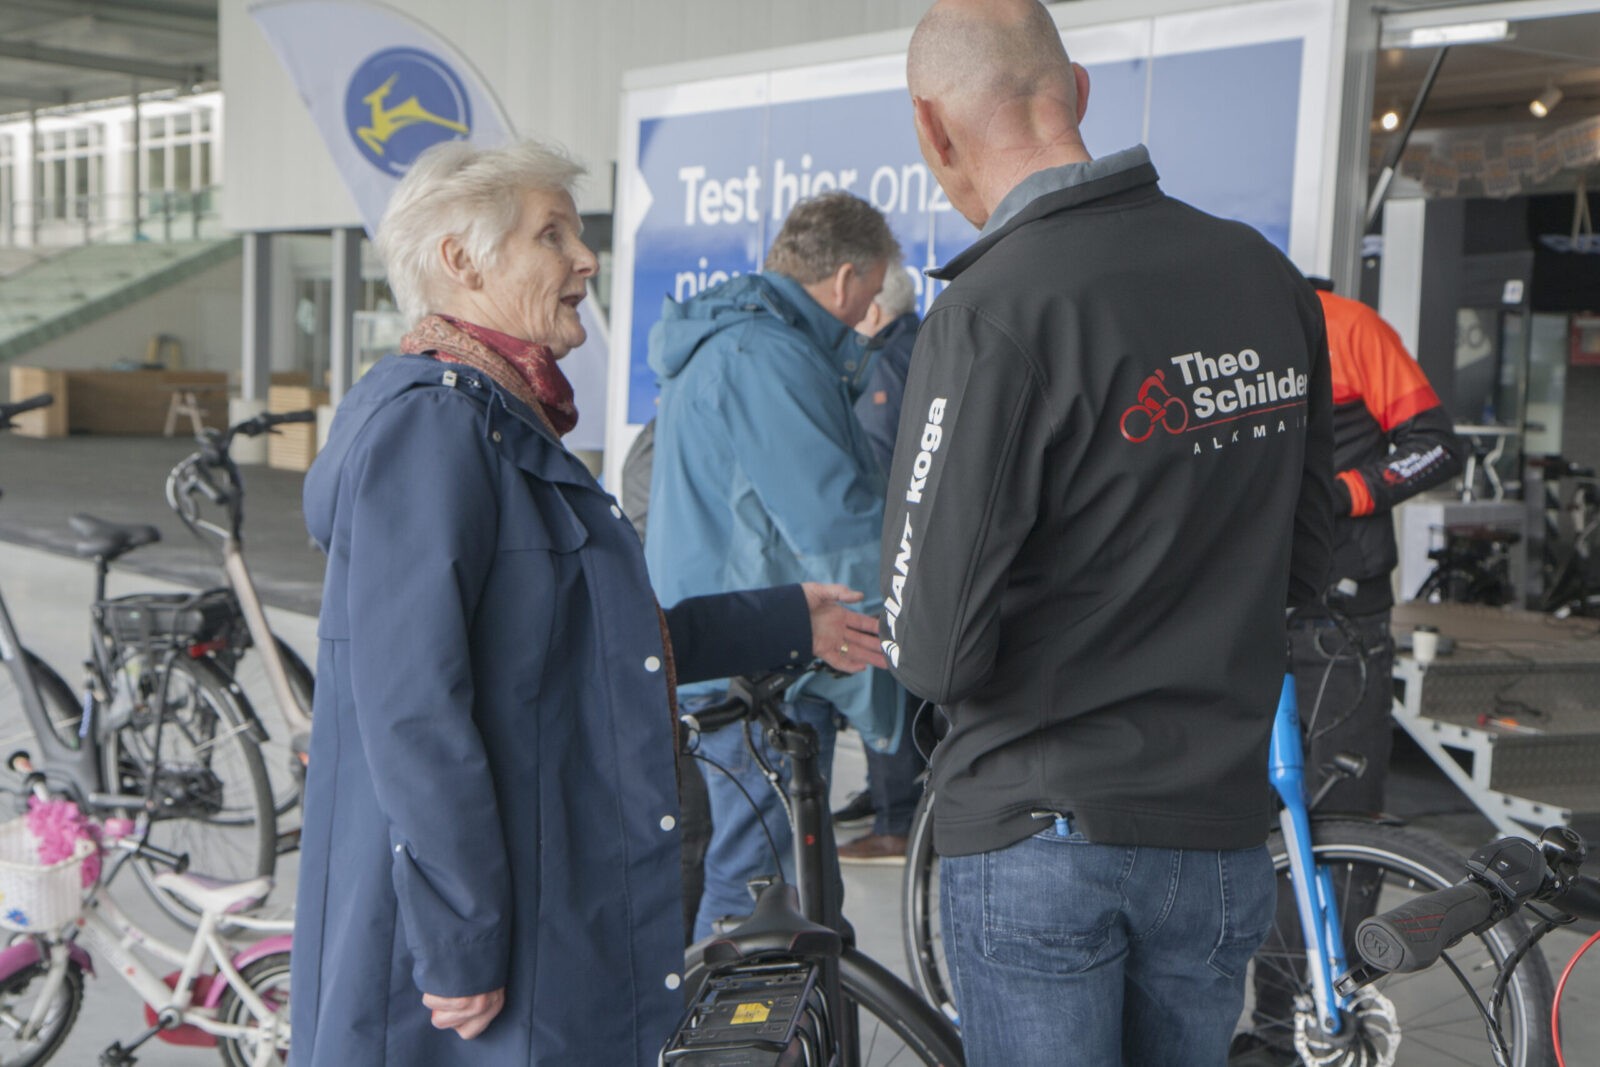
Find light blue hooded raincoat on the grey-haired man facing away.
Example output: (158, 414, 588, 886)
(645, 274, 901, 747)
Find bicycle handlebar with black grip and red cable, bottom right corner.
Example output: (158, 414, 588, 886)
(1339, 825, 1600, 1067)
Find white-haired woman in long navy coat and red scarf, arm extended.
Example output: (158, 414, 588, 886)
(291, 142, 883, 1067)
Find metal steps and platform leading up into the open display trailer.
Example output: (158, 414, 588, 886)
(1394, 603, 1600, 841)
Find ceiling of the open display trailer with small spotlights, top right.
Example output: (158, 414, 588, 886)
(1373, 13, 1600, 133)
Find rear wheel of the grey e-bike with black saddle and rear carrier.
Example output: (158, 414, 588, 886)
(102, 656, 277, 926)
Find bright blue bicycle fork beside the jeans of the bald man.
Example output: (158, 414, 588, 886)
(1267, 675, 1349, 1033)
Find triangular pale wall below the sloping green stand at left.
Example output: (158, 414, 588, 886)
(14, 256, 243, 374)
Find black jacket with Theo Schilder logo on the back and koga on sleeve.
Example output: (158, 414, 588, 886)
(883, 163, 1333, 854)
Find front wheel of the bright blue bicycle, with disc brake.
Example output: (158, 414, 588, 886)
(1235, 819, 1554, 1067)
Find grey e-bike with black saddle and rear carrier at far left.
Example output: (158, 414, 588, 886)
(0, 397, 277, 925)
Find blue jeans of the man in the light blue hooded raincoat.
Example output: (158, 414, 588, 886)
(694, 697, 837, 941)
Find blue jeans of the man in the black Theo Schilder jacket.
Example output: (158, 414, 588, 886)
(939, 830, 1275, 1067)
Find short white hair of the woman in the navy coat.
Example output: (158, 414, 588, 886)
(374, 141, 584, 323)
